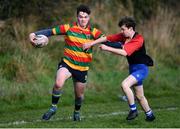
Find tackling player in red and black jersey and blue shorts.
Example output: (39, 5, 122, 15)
(83, 17, 155, 121)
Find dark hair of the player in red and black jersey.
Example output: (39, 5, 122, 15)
(118, 16, 136, 30)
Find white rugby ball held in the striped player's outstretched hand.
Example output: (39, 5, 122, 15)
(34, 35, 49, 47)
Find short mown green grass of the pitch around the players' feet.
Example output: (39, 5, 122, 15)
(0, 97, 180, 128)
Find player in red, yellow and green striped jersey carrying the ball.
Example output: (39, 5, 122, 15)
(29, 5, 103, 121)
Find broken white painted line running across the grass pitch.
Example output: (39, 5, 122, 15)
(0, 107, 178, 127)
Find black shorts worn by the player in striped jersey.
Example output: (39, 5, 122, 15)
(58, 61, 88, 83)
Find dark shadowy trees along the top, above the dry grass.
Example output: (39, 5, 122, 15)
(0, 0, 180, 20)
